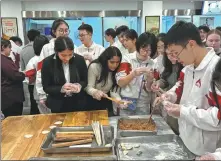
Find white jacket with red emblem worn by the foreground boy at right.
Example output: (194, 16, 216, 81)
(169, 48, 221, 155)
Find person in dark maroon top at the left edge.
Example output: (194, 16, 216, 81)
(1, 39, 25, 117)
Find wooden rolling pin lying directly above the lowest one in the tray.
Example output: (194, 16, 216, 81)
(54, 135, 94, 141)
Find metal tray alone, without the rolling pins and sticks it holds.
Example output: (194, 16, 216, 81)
(41, 126, 114, 153)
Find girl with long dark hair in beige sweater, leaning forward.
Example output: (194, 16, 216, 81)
(85, 46, 122, 117)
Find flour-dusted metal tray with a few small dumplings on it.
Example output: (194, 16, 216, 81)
(115, 134, 195, 160)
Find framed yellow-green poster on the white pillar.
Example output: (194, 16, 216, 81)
(145, 16, 160, 36)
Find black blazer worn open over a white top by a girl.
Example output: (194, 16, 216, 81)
(41, 54, 87, 109)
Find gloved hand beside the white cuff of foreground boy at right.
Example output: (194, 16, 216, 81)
(163, 101, 181, 118)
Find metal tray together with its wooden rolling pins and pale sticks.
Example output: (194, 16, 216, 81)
(41, 122, 114, 153)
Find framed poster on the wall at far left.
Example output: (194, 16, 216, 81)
(1, 18, 18, 37)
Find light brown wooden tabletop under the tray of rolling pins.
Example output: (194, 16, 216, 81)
(1, 111, 109, 160)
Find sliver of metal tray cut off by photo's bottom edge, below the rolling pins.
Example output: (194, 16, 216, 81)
(29, 155, 117, 161)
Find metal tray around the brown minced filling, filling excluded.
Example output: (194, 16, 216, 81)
(117, 117, 157, 137)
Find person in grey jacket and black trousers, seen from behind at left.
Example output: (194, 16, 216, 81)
(20, 29, 40, 114)
